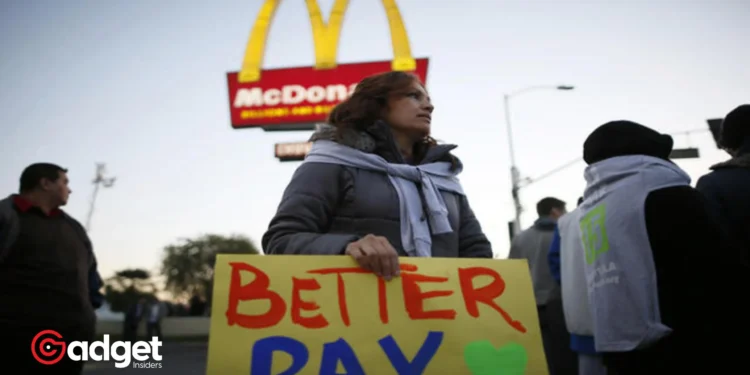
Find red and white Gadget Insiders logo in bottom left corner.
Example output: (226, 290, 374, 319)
(31, 329, 162, 368)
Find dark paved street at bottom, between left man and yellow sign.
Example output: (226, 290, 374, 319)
(83, 342, 208, 375)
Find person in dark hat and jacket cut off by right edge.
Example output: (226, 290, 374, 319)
(696, 104, 750, 262)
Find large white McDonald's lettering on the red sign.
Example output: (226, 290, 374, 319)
(233, 84, 357, 108)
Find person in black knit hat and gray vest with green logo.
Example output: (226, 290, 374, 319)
(576, 121, 747, 375)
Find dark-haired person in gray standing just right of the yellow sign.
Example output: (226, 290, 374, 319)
(508, 197, 578, 375)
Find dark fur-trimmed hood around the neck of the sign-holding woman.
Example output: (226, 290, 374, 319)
(310, 121, 462, 169)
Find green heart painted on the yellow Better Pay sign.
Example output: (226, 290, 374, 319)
(464, 341, 529, 375)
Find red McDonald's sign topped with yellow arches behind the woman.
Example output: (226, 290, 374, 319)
(227, 0, 428, 130)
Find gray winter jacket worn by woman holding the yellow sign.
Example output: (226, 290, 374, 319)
(262, 122, 492, 258)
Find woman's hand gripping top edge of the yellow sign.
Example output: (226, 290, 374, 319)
(346, 234, 401, 281)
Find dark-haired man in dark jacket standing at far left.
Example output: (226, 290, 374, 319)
(0, 163, 102, 374)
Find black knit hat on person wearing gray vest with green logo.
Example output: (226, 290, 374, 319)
(583, 120, 674, 164)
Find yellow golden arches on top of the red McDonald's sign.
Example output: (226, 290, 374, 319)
(237, 0, 417, 83)
